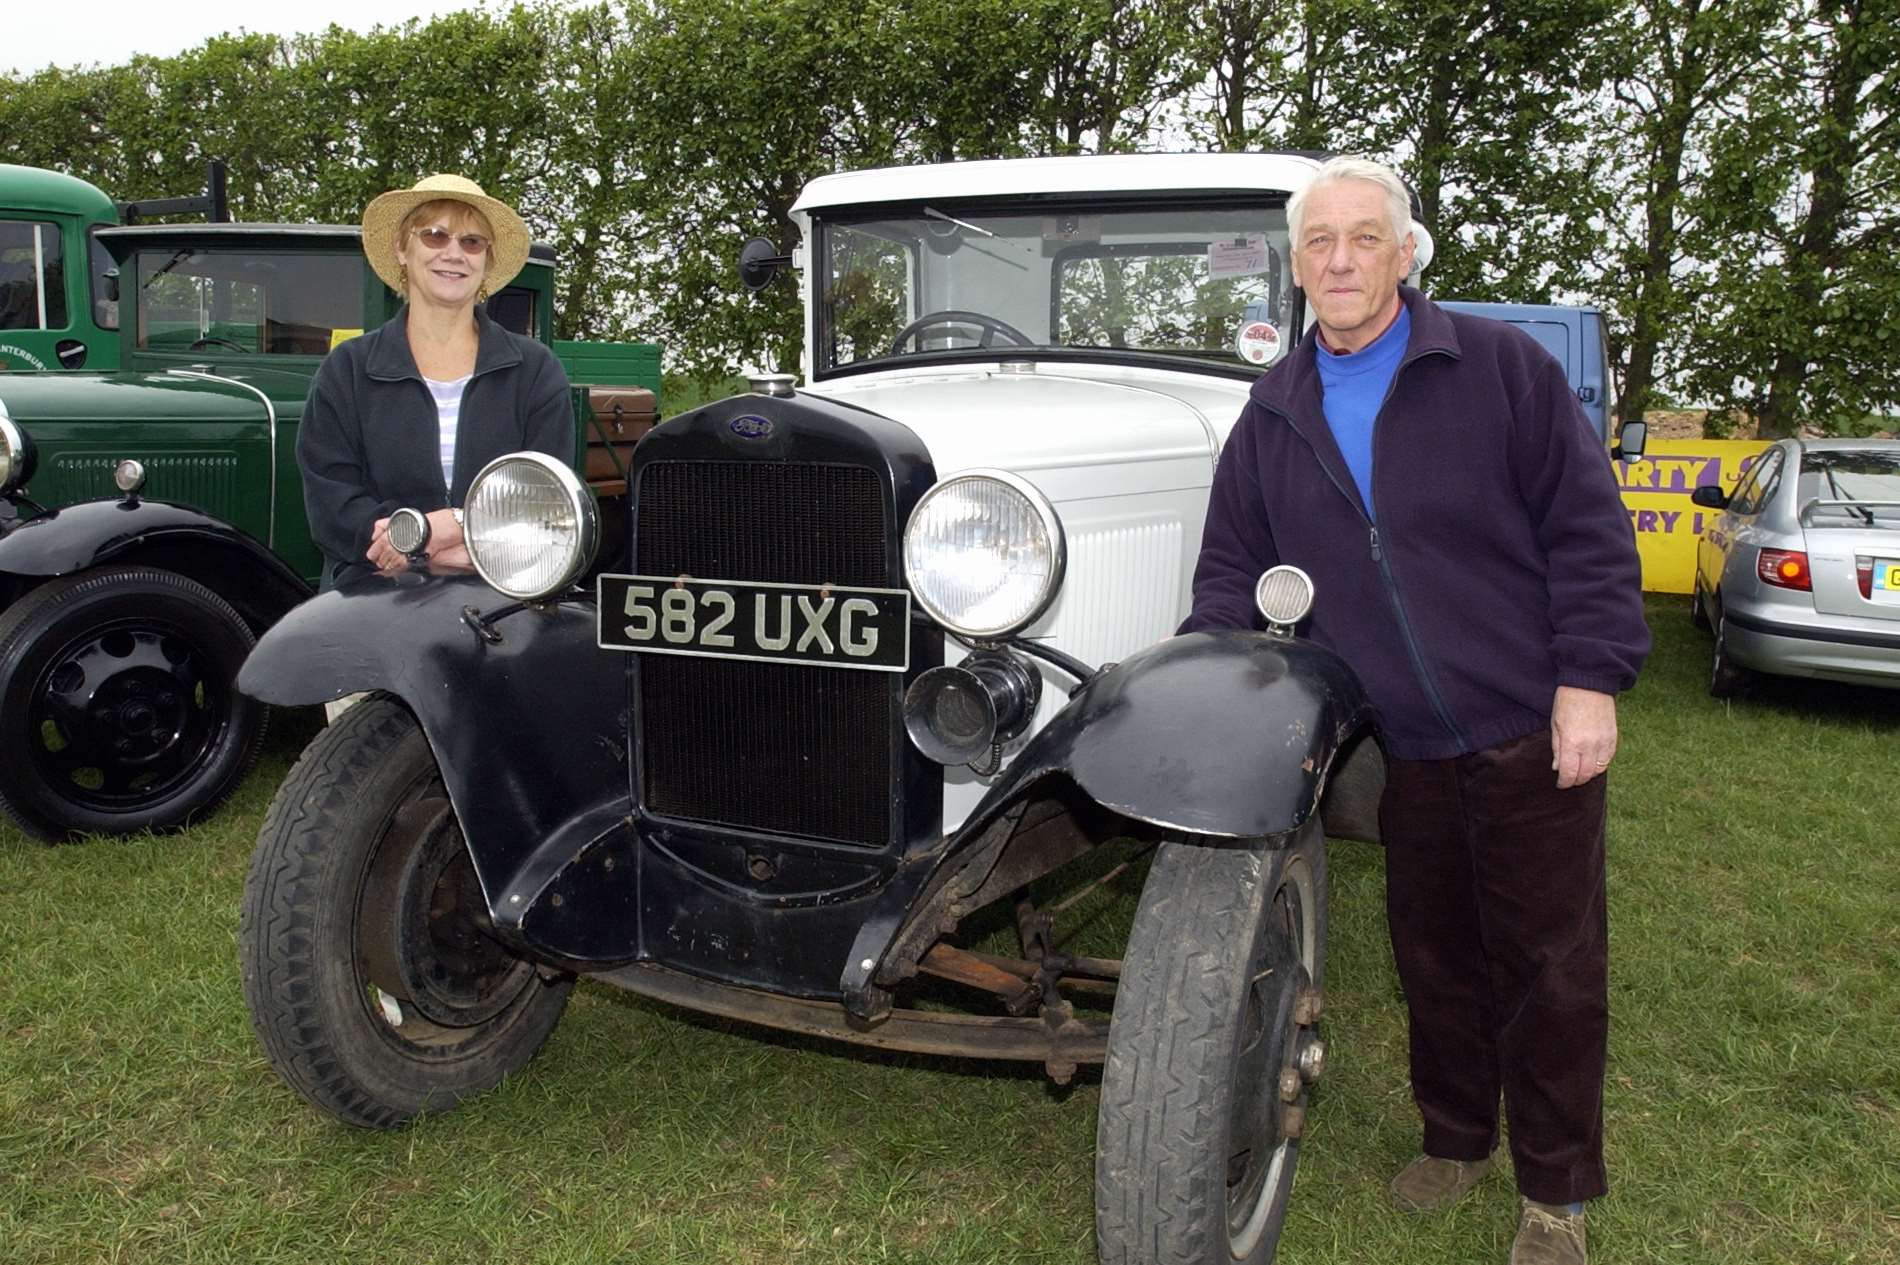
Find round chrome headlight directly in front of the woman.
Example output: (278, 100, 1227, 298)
(462, 452, 600, 602)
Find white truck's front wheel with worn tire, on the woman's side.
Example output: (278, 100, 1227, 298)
(238, 697, 574, 1128)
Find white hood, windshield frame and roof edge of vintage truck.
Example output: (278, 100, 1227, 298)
(792, 154, 1319, 830)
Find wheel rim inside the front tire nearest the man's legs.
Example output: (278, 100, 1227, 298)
(1227, 859, 1315, 1259)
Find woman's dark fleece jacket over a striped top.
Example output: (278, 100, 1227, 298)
(296, 304, 576, 589)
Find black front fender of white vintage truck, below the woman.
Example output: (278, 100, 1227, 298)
(238, 574, 633, 955)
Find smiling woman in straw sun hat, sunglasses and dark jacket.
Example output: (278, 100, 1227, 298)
(296, 175, 574, 589)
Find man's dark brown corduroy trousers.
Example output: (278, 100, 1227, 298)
(1379, 731, 1609, 1204)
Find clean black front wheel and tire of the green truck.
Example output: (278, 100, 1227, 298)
(0, 566, 268, 843)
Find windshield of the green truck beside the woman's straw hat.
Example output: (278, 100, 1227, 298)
(135, 243, 365, 355)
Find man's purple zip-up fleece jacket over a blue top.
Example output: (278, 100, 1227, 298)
(1182, 287, 1649, 760)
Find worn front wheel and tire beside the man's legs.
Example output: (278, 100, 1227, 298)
(1094, 817, 1326, 1265)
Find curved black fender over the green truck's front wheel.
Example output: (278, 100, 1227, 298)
(0, 500, 312, 631)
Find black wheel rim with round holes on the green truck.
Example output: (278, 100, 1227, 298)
(25, 619, 232, 813)
